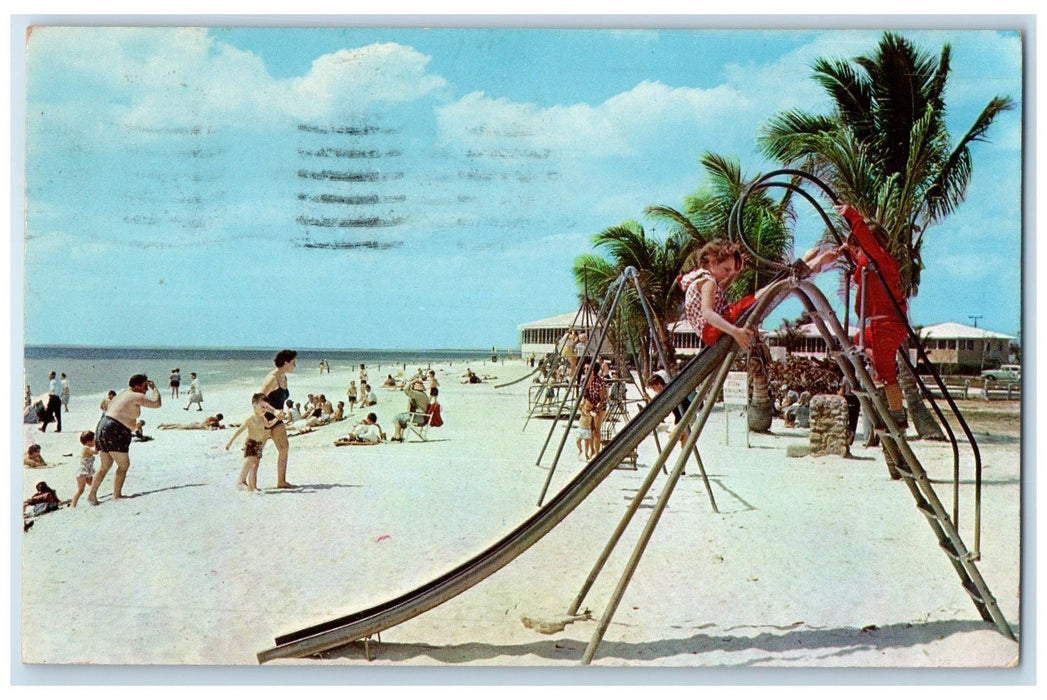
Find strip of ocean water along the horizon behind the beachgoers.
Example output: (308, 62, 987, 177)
(24, 345, 502, 406)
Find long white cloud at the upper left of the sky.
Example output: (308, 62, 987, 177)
(27, 27, 446, 132)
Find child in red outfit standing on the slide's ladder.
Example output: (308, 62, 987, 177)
(805, 204, 908, 428)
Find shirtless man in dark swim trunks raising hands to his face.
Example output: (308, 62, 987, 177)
(87, 375, 160, 505)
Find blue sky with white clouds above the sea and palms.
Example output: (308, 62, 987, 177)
(18, 21, 1022, 347)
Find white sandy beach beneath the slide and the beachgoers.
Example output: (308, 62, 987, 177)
(16, 363, 1021, 668)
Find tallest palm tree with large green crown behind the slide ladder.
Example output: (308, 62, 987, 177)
(758, 32, 1013, 437)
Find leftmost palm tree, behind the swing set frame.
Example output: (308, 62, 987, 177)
(573, 221, 694, 376)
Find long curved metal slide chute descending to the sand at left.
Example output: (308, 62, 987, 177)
(258, 328, 737, 663)
